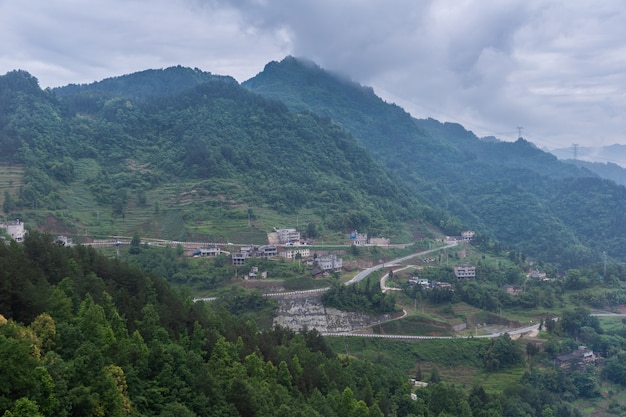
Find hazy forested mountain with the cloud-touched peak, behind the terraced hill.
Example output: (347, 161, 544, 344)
(243, 57, 626, 266)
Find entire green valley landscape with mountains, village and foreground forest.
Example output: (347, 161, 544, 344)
(0, 61, 626, 417)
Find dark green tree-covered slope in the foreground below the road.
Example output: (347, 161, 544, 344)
(0, 232, 578, 417)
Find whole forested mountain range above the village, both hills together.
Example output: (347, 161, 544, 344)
(0, 57, 626, 267)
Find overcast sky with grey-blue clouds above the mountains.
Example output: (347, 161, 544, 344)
(0, 0, 626, 154)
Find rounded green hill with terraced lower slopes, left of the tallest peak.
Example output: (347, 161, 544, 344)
(0, 67, 418, 237)
